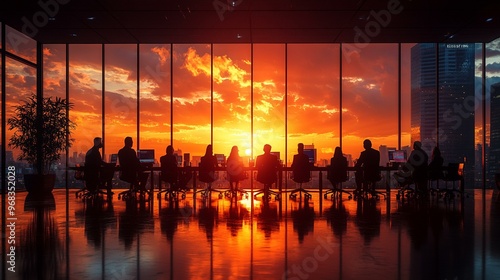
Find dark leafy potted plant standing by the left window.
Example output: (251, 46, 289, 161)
(7, 94, 76, 193)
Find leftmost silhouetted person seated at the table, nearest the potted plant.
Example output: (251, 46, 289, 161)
(84, 137, 112, 195)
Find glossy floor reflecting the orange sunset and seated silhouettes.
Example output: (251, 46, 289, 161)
(2, 186, 500, 280)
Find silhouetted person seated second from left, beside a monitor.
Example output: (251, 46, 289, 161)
(118, 136, 149, 194)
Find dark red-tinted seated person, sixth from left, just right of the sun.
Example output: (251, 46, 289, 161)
(255, 144, 279, 201)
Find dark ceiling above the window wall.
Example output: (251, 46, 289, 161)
(0, 0, 500, 44)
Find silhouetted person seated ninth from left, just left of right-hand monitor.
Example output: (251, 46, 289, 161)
(355, 139, 381, 194)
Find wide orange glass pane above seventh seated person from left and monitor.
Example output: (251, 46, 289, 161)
(287, 44, 340, 166)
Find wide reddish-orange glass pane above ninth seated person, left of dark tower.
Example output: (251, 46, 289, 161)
(342, 44, 398, 165)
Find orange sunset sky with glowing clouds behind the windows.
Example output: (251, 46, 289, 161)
(6, 39, 500, 166)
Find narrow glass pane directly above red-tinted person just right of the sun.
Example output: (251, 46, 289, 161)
(253, 44, 287, 163)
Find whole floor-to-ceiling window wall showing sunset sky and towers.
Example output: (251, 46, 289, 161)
(4, 35, 500, 189)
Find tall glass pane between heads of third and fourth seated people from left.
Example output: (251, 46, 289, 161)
(172, 44, 211, 166)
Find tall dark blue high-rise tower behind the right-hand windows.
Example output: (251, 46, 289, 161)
(411, 43, 475, 187)
